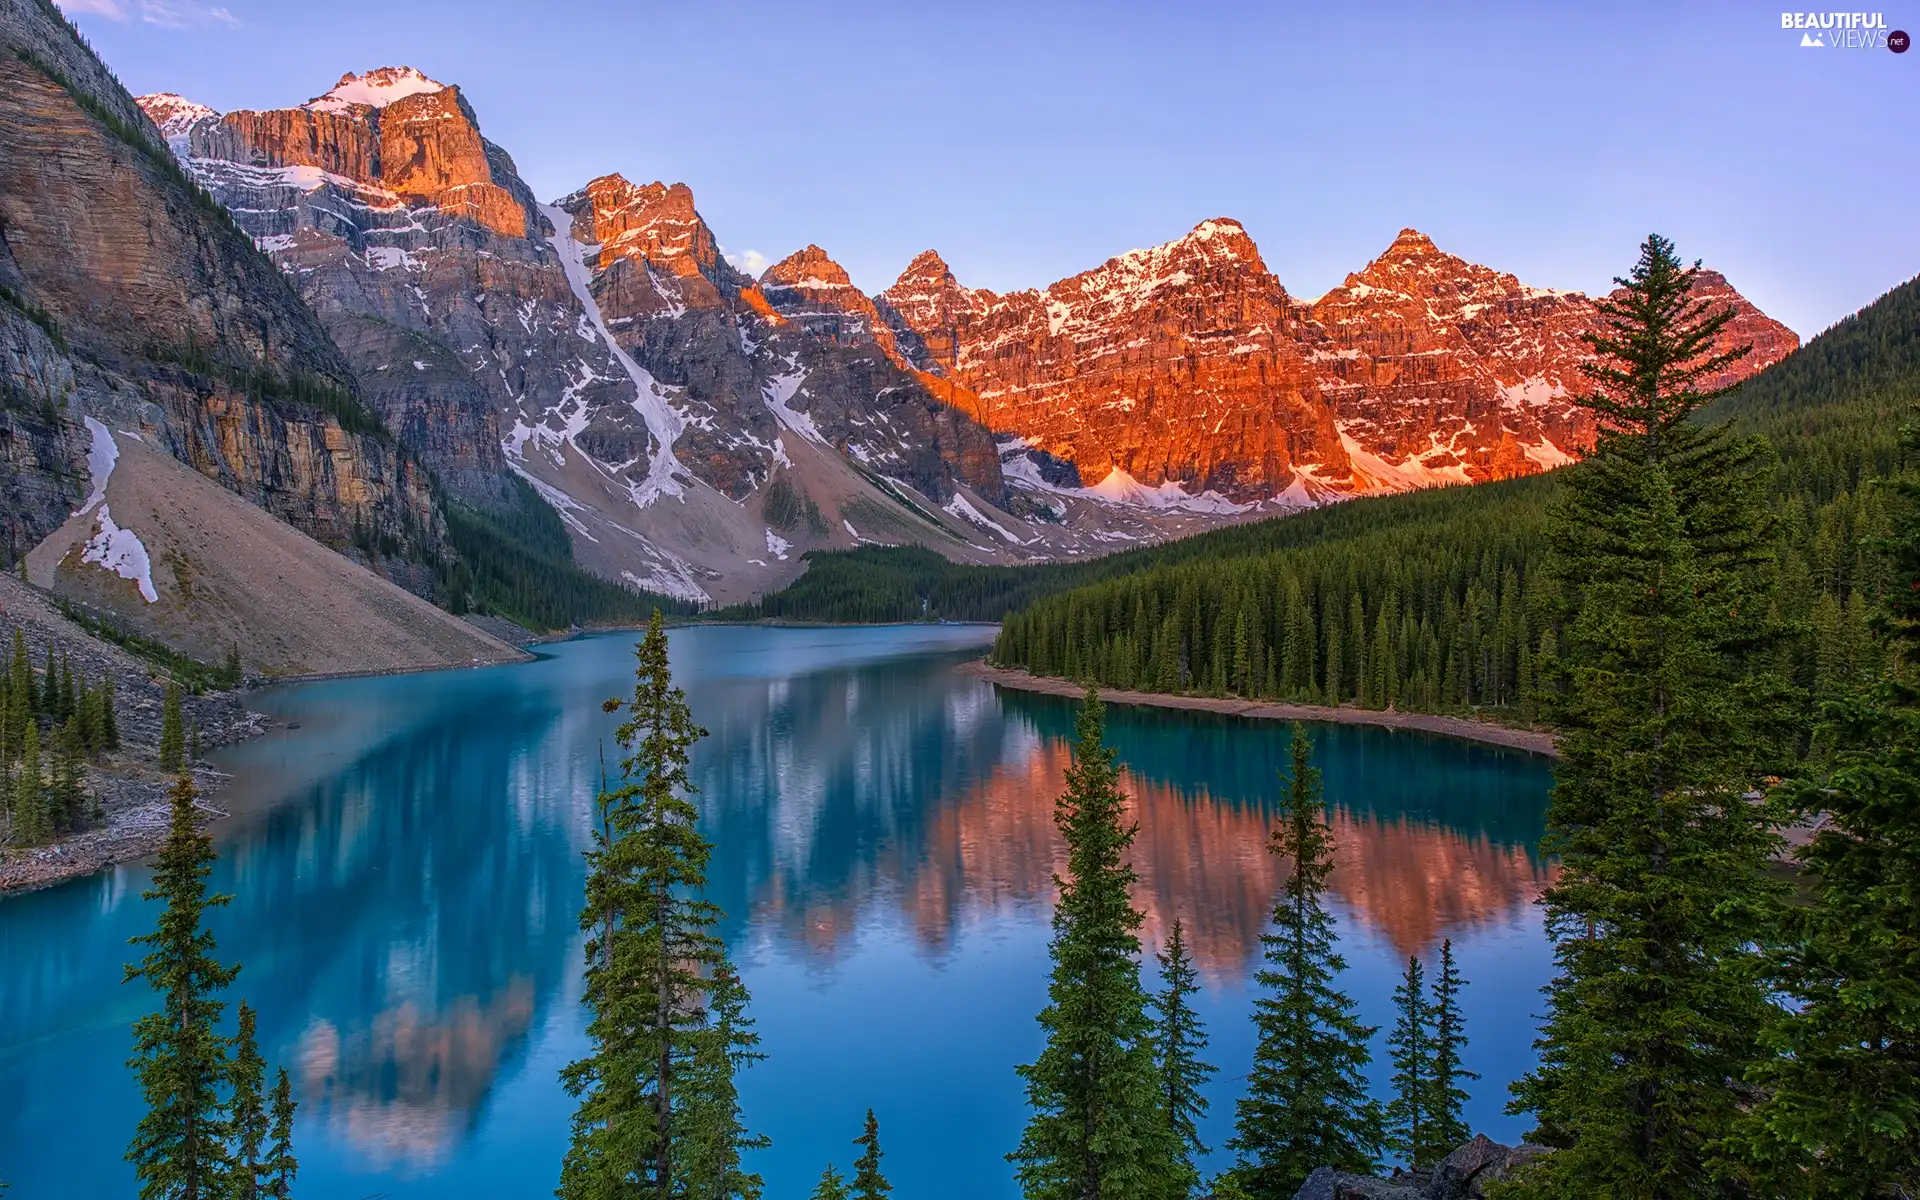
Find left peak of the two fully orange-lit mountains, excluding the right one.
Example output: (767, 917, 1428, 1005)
(881, 219, 1346, 497)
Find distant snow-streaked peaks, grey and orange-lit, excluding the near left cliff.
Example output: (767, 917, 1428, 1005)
(138, 67, 1795, 603)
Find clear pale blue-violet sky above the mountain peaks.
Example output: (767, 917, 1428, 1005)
(61, 0, 1920, 334)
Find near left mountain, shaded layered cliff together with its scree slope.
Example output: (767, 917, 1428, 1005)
(0, 0, 537, 670)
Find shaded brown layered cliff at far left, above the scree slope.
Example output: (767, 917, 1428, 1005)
(0, 0, 440, 586)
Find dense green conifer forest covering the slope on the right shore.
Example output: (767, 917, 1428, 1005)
(995, 282, 1920, 720)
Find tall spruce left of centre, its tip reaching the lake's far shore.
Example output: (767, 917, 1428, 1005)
(559, 612, 758, 1200)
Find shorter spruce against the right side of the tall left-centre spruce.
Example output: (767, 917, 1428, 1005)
(674, 960, 772, 1200)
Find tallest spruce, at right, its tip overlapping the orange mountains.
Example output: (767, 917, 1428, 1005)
(1511, 236, 1795, 1196)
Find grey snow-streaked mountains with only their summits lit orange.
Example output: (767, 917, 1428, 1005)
(140, 67, 1297, 603)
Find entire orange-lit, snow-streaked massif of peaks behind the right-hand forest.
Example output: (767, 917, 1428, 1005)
(879, 219, 1799, 499)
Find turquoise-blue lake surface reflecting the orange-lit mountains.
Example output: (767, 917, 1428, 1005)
(0, 626, 1551, 1200)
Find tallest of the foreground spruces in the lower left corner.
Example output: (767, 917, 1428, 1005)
(127, 776, 240, 1200)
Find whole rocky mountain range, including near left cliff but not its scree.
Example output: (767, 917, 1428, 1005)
(0, 0, 1797, 656)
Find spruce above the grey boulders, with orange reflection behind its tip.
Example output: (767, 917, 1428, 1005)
(1227, 724, 1382, 1200)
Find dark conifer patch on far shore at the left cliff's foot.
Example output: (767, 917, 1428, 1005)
(438, 476, 693, 630)
